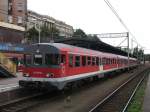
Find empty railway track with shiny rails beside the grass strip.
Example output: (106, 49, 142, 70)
(89, 70, 150, 112)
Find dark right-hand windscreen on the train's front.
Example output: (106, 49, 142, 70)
(45, 54, 60, 65)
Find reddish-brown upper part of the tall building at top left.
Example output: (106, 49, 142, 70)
(0, 0, 27, 27)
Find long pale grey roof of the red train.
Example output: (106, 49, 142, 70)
(26, 43, 136, 59)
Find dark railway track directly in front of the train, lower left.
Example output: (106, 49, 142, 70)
(0, 88, 59, 112)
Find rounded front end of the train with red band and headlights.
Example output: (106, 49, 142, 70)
(19, 44, 64, 89)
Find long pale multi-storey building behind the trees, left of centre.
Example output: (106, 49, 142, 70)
(27, 10, 74, 38)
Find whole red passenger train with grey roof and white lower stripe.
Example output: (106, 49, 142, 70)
(19, 43, 137, 89)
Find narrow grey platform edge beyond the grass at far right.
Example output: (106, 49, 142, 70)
(143, 76, 150, 112)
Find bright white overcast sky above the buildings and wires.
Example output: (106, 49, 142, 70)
(28, 0, 150, 53)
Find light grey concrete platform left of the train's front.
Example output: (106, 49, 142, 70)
(0, 73, 23, 92)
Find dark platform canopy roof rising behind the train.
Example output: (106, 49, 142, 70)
(55, 37, 133, 57)
